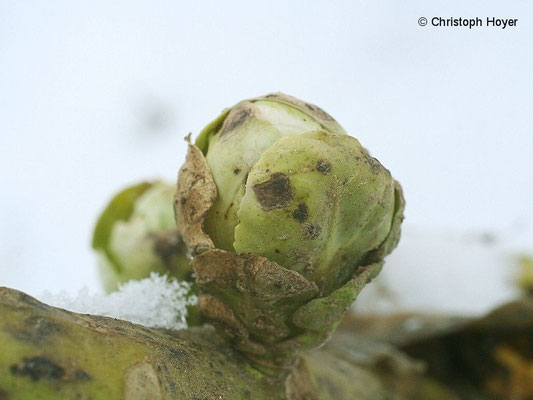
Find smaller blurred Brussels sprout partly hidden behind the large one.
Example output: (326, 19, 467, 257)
(92, 182, 192, 292)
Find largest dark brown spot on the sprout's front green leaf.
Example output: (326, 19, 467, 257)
(253, 172, 292, 211)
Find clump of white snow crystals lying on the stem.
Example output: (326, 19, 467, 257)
(41, 273, 197, 329)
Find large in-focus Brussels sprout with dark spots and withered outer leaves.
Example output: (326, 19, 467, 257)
(175, 93, 404, 368)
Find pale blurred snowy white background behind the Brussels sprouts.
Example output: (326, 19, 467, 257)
(0, 0, 533, 314)
